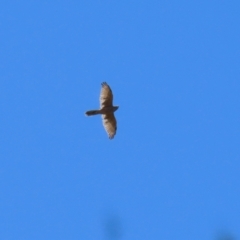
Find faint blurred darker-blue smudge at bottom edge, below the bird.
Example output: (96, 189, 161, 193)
(105, 215, 122, 240)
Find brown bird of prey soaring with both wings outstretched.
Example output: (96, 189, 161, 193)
(85, 82, 118, 139)
